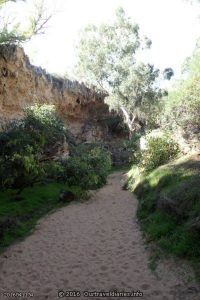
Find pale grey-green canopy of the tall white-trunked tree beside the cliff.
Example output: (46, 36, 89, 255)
(76, 8, 160, 136)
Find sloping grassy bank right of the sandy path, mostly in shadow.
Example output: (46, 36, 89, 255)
(128, 156, 200, 280)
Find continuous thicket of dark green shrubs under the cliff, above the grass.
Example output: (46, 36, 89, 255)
(0, 105, 111, 190)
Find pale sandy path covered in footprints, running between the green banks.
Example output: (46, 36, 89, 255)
(0, 173, 200, 300)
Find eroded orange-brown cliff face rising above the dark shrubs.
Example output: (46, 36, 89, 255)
(0, 45, 109, 142)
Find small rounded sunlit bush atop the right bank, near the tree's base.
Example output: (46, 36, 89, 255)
(140, 136, 179, 172)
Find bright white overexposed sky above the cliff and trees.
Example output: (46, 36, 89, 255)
(4, 0, 200, 76)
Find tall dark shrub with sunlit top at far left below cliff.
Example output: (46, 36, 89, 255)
(0, 105, 64, 189)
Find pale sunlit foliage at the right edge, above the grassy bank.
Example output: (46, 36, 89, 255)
(162, 43, 200, 129)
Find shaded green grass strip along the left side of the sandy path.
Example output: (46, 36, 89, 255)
(0, 183, 83, 252)
